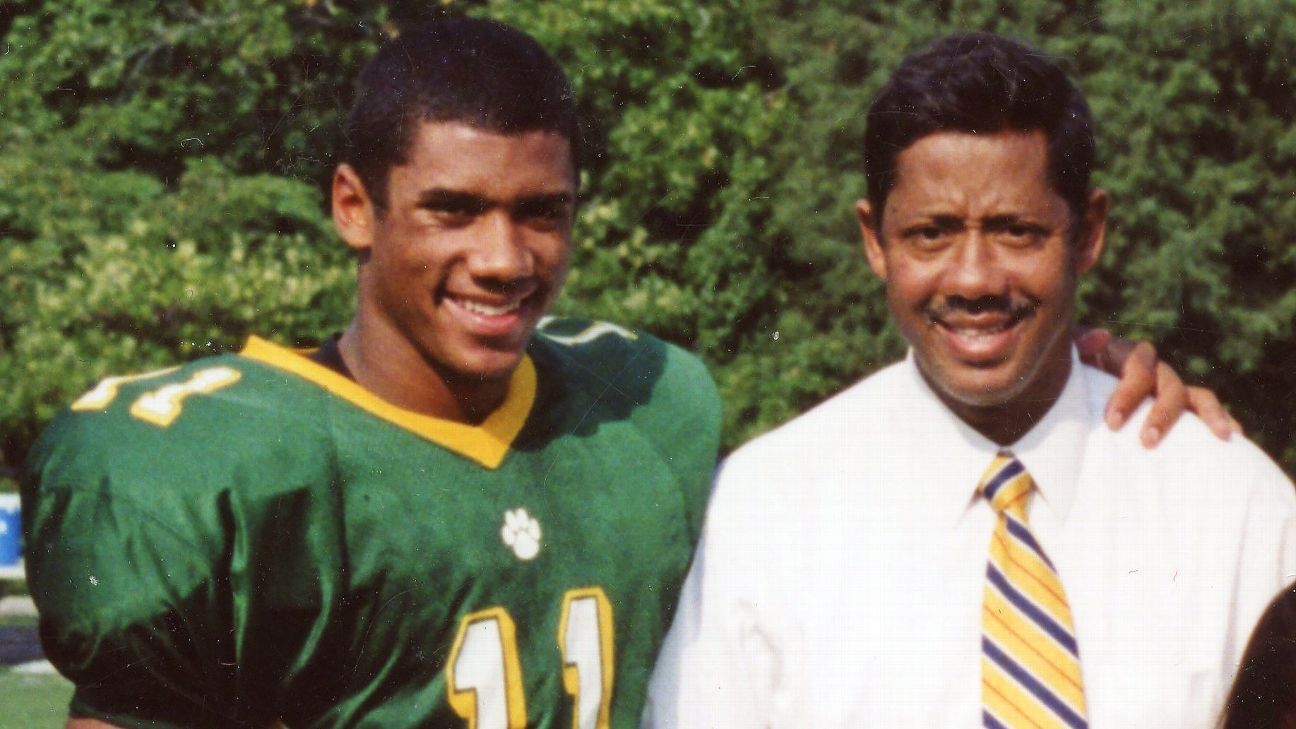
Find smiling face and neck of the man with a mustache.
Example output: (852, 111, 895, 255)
(857, 127, 1107, 444)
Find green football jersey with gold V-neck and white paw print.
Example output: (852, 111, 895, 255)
(23, 320, 719, 729)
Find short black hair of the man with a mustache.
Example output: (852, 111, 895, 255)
(864, 32, 1094, 230)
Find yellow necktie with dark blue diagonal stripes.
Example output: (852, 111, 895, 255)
(980, 453, 1089, 729)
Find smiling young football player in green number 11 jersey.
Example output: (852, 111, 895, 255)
(23, 12, 1223, 729)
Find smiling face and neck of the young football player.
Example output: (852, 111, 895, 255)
(333, 122, 575, 419)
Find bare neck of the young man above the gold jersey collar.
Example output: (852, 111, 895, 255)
(338, 318, 509, 425)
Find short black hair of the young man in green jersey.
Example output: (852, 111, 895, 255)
(342, 18, 577, 210)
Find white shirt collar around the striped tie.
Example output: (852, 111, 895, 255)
(903, 350, 1100, 525)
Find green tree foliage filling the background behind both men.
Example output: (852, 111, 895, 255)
(0, 0, 1296, 471)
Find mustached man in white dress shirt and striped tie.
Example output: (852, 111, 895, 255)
(645, 34, 1296, 728)
